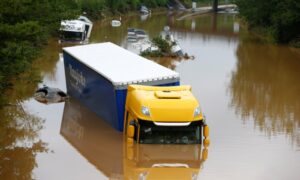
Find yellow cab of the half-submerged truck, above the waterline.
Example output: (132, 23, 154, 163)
(124, 85, 209, 144)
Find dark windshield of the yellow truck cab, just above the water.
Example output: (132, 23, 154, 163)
(139, 120, 201, 144)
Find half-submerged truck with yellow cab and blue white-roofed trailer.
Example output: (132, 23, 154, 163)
(63, 42, 209, 144)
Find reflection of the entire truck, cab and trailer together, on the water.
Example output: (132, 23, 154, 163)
(60, 98, 208, 179)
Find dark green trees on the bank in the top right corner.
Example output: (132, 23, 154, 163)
(236, 0, 300, 43)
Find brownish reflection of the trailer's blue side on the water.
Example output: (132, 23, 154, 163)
(60, 98, 123, 178)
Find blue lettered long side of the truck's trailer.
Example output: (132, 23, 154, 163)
(63, 53, 119, 131)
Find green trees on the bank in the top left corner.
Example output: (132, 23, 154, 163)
(0, 0, 79, 100)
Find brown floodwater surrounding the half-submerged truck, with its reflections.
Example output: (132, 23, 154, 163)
(0, 12, 300, 180)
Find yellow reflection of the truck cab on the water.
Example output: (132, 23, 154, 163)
(123, 144, 208, 180)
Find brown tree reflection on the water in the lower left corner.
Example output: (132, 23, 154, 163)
(0, 104, 47, 179)
